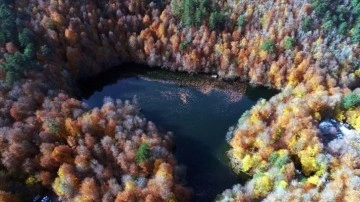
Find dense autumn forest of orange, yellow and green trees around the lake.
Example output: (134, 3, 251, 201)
(0, 0, 360, 202)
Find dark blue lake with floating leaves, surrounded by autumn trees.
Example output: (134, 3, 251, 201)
(80, 65, 275, 201)
